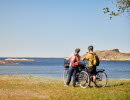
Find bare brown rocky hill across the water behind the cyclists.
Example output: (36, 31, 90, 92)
(82, 49, 130, 61)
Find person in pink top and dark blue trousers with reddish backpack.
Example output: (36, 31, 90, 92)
(65, 48, 80, 87)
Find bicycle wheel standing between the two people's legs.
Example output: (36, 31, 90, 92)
(78, 71, 89, 88)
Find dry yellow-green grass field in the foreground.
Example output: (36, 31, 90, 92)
(0, 75, 130, 100)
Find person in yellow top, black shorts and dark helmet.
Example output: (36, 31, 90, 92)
(85, 45, 97, 87)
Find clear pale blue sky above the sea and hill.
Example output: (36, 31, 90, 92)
(0, 0, 130, 57)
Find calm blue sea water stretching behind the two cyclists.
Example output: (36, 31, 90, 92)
(0, 58, 130, 79)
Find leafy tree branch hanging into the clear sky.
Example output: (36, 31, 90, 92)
(103, 0, 130, 19)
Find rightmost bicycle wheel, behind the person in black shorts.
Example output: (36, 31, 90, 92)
(96, 72, 108, 87)
